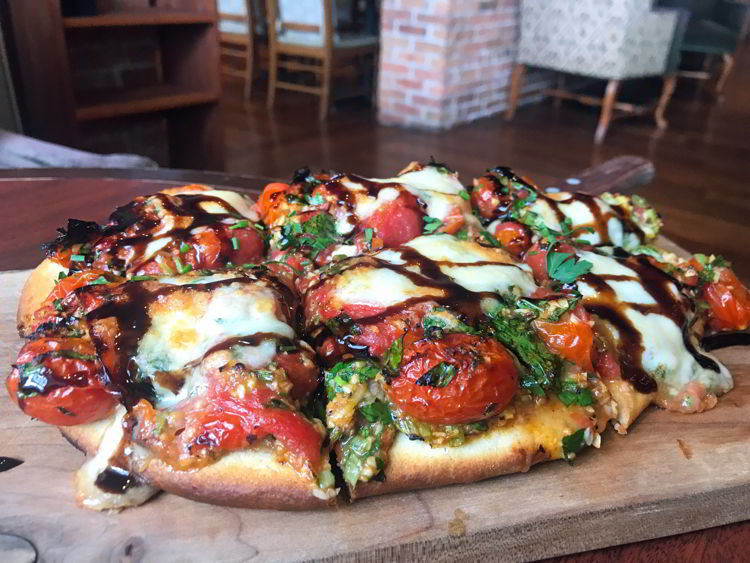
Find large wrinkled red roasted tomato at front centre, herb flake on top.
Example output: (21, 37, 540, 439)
(388, 334, 518, 424)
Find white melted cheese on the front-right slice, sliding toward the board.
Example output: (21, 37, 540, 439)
(577, 251, 732, 398)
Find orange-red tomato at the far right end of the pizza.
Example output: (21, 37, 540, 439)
(702, 268, 750, 330)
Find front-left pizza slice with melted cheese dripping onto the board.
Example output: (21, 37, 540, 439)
(7, 268, 337, 509)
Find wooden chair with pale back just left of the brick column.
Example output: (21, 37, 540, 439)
(266, 0, 378, 120)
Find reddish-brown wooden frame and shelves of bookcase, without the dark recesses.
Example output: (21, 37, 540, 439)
(0, 0, 224, 170)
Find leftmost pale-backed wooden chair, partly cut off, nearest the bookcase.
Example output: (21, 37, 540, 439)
(218, 0, 268, 100)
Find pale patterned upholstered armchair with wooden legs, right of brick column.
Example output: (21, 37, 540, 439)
(507, 0, 685, 143)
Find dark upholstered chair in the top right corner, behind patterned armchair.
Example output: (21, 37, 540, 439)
(659, 0, 750, 94)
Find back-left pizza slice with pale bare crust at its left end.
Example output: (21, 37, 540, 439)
(19, 185, 265, 335)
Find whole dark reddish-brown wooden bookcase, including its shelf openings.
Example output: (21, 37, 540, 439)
(3, 0, 223, 169)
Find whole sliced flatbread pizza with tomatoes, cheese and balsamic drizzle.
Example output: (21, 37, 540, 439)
(7, 162, 750, 510)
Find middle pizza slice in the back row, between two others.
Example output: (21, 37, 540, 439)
(257, 162, 478, 272)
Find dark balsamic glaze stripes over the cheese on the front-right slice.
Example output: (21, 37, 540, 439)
(580, 251, 720, 393)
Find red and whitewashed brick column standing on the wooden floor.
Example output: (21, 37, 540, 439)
(378, 0, 551, 129)
